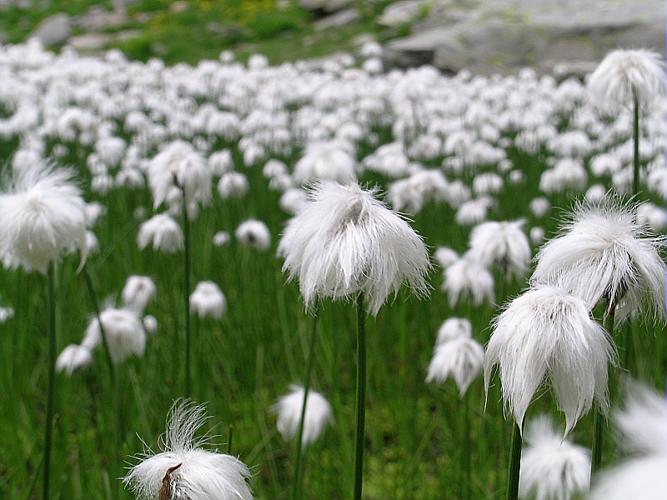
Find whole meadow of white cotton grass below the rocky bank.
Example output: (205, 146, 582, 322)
(0, 42, 667, 500)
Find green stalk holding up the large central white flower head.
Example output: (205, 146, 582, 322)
(353, 293, 366, 500)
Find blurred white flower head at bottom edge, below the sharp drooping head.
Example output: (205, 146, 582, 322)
(519, 415, 591, 500)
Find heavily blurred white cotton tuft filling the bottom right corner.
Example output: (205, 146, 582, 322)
(590, 384, 667, 500)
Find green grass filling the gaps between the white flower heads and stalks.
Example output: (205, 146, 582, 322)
(0, 127, 667, 500)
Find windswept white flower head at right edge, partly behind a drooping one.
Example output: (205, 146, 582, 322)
(531, 198, 665, 319)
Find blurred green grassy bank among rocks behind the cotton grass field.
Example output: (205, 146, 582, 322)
(0, 0, 396, 64)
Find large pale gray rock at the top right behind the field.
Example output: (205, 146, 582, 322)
(383, 0, 664, 74)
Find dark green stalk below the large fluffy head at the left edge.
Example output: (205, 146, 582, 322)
(42, 262, 56, 500)
